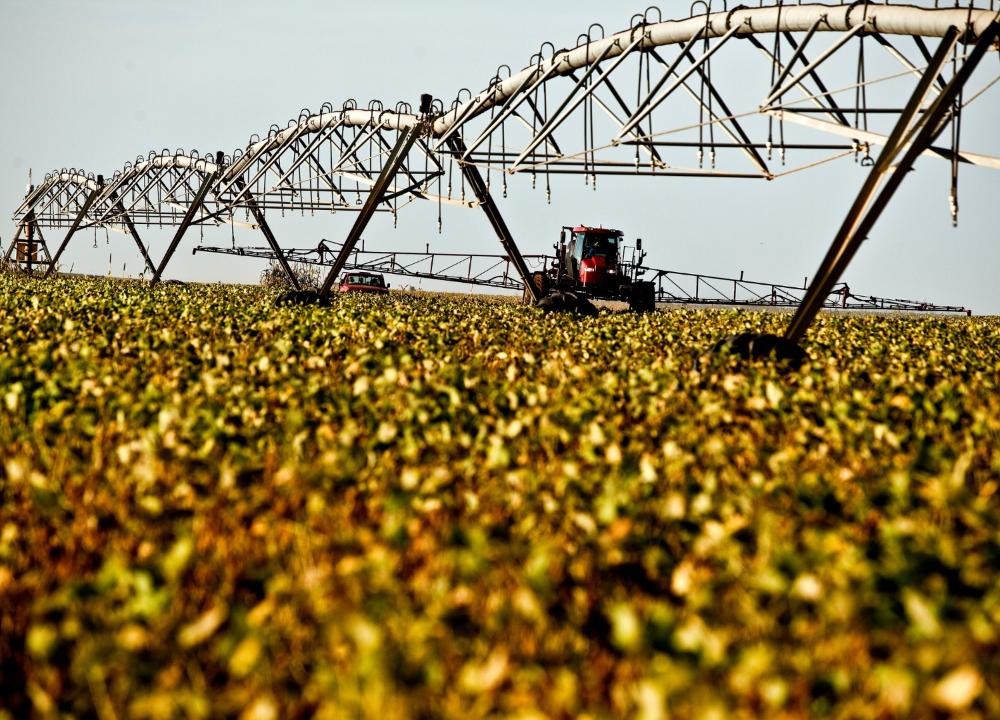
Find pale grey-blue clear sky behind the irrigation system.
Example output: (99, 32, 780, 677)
(0, 0, 1000, 314)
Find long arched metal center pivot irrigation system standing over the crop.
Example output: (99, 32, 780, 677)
(5, 0, 1000, 353)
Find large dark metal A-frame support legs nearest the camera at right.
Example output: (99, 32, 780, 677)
(785, 22, 1000, 343)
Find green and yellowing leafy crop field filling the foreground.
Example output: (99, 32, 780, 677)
(0, 275, 1000, 720)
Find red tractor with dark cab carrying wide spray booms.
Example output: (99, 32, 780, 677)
(526, 225, 656, 313)
